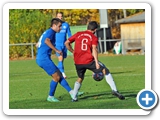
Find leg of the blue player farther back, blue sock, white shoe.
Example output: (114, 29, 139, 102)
(56, 46, 67, 79)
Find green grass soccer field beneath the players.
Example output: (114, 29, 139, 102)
(9, 55, 145, 109)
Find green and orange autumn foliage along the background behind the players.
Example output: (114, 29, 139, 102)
(9, 9, 144, 58)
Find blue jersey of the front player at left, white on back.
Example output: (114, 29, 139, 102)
(36, 28, 56, 59)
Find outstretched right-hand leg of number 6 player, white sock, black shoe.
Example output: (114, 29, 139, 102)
(99, 62, 125, 100)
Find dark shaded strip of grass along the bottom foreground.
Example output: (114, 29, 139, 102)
(9, 91, 137, 109)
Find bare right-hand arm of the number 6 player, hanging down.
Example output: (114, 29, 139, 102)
(92, 45, 100, 69)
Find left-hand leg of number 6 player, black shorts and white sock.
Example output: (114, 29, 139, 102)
(72, 65, 86, 102)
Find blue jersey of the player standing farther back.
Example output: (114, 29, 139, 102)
(56, 22, 71, 46)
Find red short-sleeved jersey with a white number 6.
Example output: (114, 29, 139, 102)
(68, 31, 98, 64)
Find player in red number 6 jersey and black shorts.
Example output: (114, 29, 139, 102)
(65, 21, 125, 102)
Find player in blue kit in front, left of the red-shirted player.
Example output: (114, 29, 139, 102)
(36, 18, 72, 102)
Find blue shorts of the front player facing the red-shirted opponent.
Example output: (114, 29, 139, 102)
(36, 59, 58, 76)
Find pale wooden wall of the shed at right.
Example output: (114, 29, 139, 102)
(120, 23, 145, 49)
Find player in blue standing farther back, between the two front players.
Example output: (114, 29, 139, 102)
(55, 12, 71, 78)
